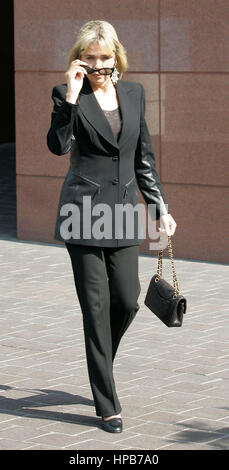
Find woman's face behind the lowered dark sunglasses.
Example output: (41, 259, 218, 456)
(81, 43, 115, 86)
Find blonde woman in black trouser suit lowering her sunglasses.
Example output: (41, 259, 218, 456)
(47, 20, 176, 432)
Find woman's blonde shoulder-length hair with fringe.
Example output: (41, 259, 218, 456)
(67, 20, 128, 78)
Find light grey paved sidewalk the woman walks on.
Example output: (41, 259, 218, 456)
(0, 237, 229, 450)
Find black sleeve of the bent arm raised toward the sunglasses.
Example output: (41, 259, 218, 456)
(47, 85, 78, 155)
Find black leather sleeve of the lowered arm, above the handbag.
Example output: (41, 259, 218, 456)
(135, 85, 168, 219)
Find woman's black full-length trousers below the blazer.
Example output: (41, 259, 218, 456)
(65, 243, 141, 417)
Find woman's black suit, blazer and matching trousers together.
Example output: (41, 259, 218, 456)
(47, 78, 166, 416)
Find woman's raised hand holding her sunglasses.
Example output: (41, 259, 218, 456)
(65, 59, 88, 104)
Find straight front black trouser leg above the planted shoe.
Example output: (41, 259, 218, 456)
(66, 243, 121, 416)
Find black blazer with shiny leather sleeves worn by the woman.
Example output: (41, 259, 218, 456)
(47, 77, 168, 247)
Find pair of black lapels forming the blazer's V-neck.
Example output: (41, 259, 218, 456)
(79, 77, 136, 148)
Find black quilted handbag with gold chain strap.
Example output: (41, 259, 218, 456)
(144, 237, 187, 327)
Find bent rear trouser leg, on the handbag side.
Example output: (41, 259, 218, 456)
(105, 245, 141, 361)
